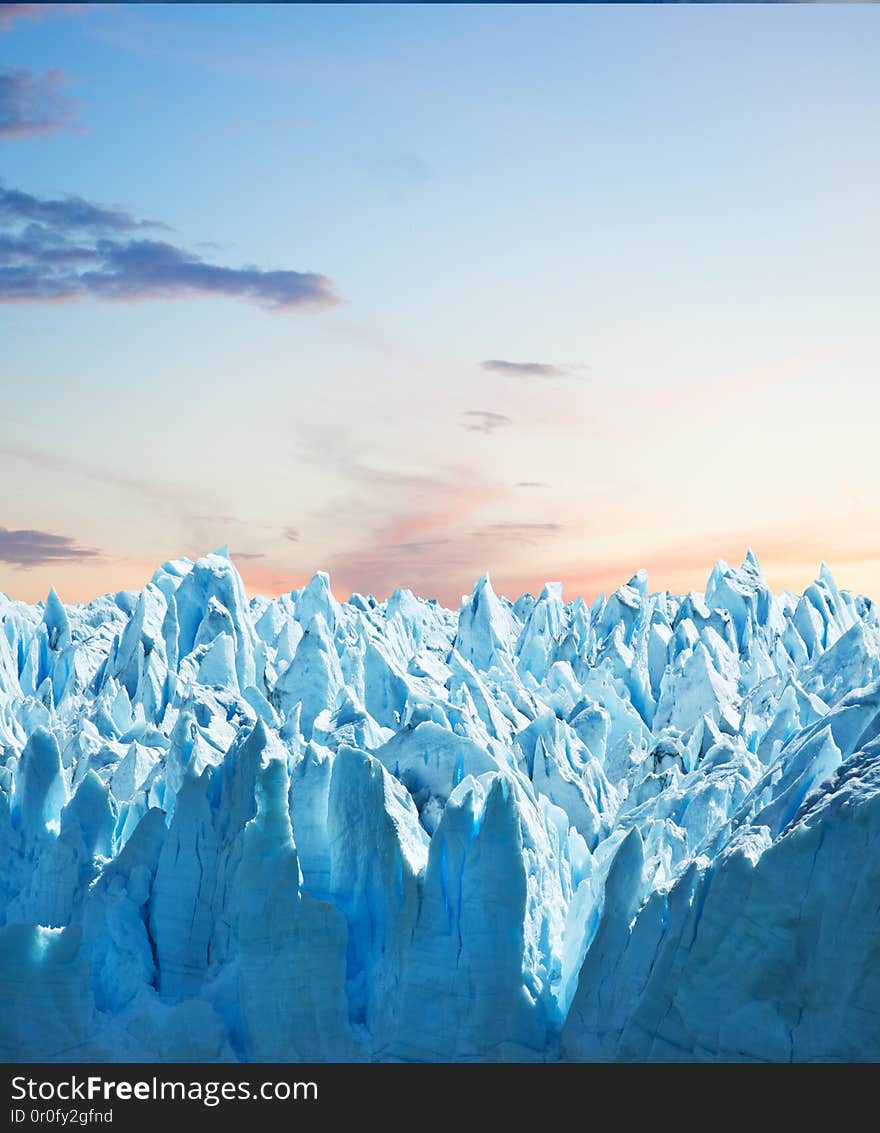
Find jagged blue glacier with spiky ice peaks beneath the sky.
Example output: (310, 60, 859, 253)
(0, 553, 880, 1060)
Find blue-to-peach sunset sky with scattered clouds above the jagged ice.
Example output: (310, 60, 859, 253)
(0, 5, 880, 606)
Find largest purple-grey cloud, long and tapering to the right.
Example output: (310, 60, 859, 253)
(0, 189, 339, 310)
